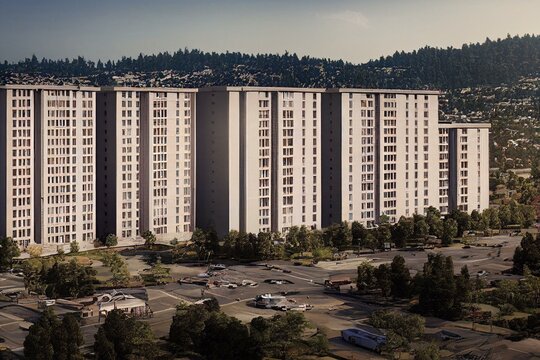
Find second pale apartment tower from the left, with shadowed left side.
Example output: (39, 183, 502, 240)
(97, 87, 196, 242)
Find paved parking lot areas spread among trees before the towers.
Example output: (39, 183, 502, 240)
(0, 236, 532, 359)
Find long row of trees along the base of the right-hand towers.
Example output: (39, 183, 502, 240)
(185, 202, 536, 260)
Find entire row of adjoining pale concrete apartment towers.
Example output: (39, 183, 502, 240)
(0, 85, 490, 247)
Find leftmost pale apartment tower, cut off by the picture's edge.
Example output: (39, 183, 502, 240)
(0, 85, 98, 247)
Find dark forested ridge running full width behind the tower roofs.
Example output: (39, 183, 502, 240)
(0, 35, 540, 89)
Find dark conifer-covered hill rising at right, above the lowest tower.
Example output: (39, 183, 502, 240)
(362, 35, 540, 89)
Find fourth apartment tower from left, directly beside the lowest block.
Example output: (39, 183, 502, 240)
(323, 89, 439, 227)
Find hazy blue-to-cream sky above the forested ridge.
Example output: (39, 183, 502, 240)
(0, 0, 540, 63)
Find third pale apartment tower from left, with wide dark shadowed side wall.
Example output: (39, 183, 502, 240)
(197, 87, 323, 235)
